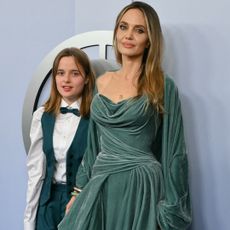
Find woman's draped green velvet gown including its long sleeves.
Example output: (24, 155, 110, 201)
(58, 78, 191, 230)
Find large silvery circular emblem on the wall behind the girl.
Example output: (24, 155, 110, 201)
(22, 31, 118, 152)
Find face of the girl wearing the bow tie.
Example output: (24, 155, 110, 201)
(55, 56, 87, 105)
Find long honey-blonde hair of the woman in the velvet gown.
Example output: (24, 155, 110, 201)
(113, 1, 164, 112)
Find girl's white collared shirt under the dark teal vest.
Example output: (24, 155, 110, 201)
(24, 100, 81, 230)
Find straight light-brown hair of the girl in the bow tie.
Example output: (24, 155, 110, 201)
(44, 47, 95, 117)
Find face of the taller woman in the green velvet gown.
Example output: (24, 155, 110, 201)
(116, 9, 149, 58)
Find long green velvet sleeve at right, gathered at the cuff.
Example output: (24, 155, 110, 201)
(157, 77, 191, 230)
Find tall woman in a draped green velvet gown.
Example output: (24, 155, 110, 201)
(59, 2, 191, 230)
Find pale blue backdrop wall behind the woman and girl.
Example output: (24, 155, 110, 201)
(0, 0, 230, 230)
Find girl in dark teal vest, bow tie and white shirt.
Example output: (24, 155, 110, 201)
(24, 48, 95, 230)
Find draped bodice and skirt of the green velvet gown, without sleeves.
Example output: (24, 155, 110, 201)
(58, 94, 164, 230)
